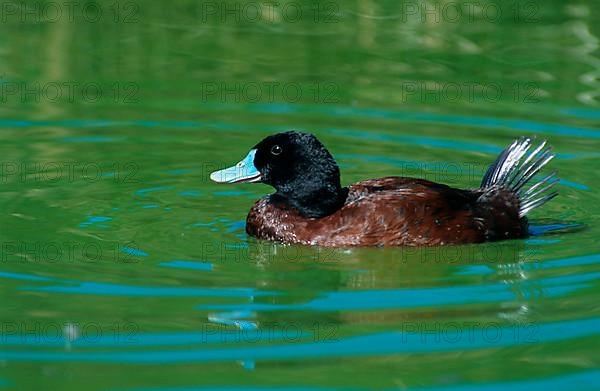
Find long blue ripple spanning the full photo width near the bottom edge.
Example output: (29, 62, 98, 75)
(0, 318, 600, 364)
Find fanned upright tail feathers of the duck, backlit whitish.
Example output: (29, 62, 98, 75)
(481, 137, 559, 217)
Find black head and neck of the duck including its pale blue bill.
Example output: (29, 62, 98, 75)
(211, 131, 347, 217)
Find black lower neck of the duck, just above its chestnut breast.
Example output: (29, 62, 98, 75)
(276, 184, 348, 218)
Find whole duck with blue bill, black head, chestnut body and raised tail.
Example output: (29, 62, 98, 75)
(210, 130, 559, 247)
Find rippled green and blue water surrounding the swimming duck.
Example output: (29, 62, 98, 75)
(0, 0, 600, 390)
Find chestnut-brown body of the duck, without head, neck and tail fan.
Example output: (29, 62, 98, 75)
(246, 177, 527, 247)
